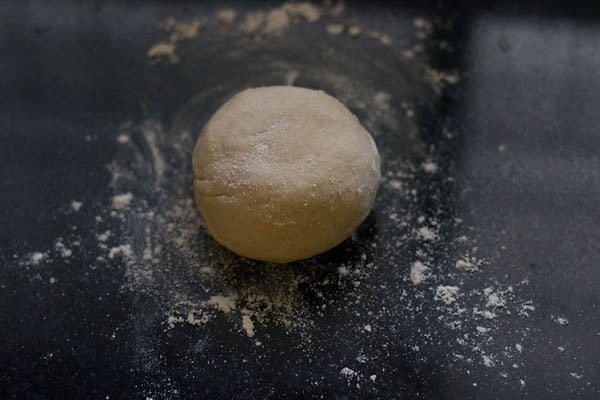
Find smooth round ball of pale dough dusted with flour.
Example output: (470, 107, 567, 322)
(193, 86, 381, 263)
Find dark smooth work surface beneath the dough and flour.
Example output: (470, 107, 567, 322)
(0, 1, 600, 399)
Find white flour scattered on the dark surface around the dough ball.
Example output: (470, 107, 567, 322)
(9, 7, 566, 396)
